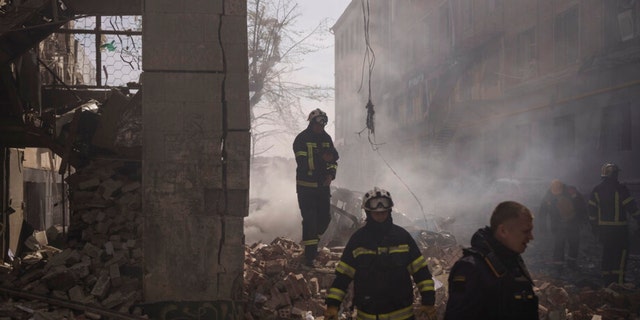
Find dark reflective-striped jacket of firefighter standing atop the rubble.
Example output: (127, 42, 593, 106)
(293, 126, 339, 188)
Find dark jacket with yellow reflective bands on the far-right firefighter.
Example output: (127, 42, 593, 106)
(589, 178, 640, 227)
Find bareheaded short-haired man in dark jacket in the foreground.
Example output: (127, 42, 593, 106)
(444, 201, 538, 320)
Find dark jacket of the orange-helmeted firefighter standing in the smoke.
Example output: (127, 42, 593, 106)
(539, 186, 587, 233)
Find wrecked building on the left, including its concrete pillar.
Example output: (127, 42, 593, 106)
(0, 0, 250, 318)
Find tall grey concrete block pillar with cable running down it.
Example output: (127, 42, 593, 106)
(142, 0, 250, 303)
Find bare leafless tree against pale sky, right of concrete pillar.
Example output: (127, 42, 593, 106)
(247, 0, 333, 156)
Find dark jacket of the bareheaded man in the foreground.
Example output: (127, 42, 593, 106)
(445, 227, 538, 320)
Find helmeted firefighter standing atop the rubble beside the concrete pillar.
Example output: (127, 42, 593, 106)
(293, 109, 339, 267)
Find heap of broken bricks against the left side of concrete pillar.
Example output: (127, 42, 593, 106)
(2, 160, 143, 319)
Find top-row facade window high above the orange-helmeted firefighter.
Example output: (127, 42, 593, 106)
(553, 6, 580, 67)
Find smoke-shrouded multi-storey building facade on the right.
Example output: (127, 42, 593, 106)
(333, 0, 640, 214)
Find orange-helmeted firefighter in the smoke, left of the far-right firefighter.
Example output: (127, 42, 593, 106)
(539, 179, 587, 270)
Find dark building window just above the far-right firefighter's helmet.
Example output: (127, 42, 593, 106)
(600, 103, 632, 151)
